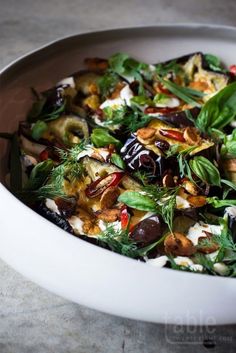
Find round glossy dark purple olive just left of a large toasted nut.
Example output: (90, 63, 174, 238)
(130, 216, 163, 246)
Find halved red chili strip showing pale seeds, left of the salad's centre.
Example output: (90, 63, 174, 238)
(85, 172, 124, 197)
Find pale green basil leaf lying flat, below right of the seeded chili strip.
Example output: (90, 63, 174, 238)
(118, 191, 156, 212)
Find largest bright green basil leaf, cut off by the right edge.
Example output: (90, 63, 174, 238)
(196, 82, 236, 132)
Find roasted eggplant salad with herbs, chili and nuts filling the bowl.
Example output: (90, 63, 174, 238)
(0, 52, 236, 277)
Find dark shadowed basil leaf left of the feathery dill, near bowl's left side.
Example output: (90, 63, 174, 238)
(25, 159, 53, 190)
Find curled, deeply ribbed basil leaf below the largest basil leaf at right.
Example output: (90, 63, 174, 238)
(189, 156, 221, 186)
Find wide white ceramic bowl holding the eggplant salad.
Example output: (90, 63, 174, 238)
(0, 25, 236, 325)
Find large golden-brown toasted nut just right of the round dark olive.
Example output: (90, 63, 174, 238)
(164, 232, 196, 256)
